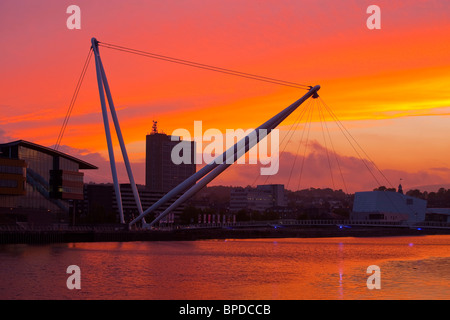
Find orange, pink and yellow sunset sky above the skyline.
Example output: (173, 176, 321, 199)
(0, 0, 450, 192)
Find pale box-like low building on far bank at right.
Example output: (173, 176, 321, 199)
(351, 191, 427, 223)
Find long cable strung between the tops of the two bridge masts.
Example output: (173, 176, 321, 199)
(99, 42, 311, 90)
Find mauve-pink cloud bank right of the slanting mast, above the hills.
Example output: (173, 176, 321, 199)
(208, 141, 450, 193)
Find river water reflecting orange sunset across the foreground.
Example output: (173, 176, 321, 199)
(0, 235, 450, 300)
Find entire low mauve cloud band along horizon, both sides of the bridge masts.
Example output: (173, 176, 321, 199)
(54, 141, 450, 193)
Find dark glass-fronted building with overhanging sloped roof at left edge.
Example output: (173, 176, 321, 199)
(0, 140, 97, 224)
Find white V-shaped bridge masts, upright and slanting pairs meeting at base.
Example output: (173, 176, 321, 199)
(91, 38, 320, 227)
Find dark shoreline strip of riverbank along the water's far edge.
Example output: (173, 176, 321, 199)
(0, 226, 450, 244)
